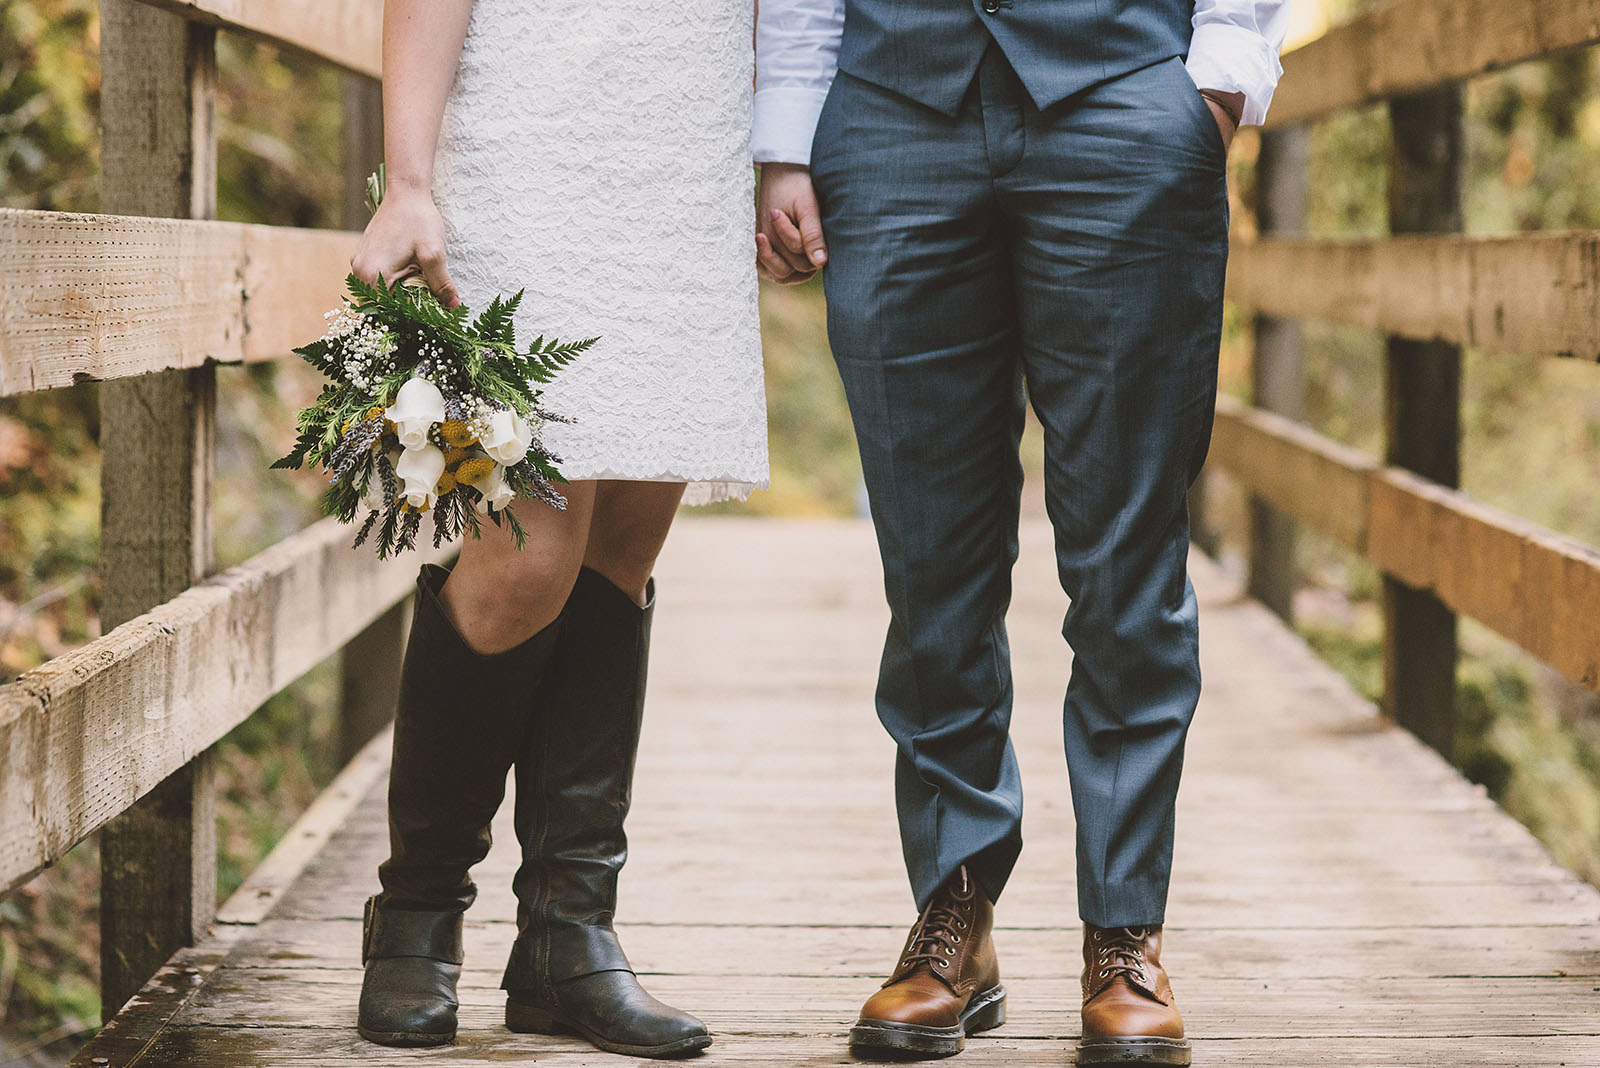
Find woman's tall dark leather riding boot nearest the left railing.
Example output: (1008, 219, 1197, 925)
(357, 564, 562, 1046)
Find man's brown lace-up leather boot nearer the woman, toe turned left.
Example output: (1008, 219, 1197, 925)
(850, 867, 1005, 1057)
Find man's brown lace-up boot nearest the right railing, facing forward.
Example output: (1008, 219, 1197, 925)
(1077, 924, 1189, 1065)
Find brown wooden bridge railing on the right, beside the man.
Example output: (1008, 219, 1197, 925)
(1211, 0, 1600, 755)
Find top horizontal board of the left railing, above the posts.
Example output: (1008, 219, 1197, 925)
(133, 0, 384, 78)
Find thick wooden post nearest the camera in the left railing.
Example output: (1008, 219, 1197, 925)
(101, 0, 216, 1018)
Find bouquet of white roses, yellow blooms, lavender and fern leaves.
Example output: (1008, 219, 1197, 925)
(274, 174, 597, 556)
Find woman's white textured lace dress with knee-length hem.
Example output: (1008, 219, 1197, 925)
(434, 0, 768, 504)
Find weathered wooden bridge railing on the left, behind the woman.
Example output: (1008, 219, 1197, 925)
(0, 0, 435, 1015)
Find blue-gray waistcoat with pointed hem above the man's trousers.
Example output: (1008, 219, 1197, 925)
(838, 0, 1194, 115)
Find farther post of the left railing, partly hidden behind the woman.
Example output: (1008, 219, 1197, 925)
(339, 74, 411, 764)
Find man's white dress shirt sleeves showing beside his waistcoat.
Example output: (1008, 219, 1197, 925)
(752, 0, 1290, 163)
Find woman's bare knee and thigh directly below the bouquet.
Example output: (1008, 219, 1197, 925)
(443, 481, 600, 654)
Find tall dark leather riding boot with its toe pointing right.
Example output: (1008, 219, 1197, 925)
(501, 568, 710, 1057)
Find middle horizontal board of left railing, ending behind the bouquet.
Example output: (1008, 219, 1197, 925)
(0, 208, 357, 397)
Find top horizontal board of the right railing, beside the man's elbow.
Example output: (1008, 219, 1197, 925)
(1269, 0, 1600, 126)
